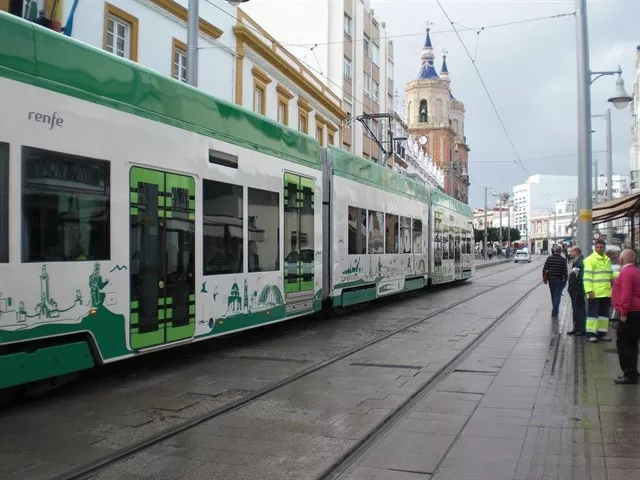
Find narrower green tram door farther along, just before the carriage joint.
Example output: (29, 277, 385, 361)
(284, 173, 315, 304)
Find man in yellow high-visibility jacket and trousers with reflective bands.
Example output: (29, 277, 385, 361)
(583, 239, 617, 342)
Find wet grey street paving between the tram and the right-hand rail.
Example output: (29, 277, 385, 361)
(0, 264, 538, 480)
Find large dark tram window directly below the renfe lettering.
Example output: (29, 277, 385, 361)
(22, 147, 111, 262)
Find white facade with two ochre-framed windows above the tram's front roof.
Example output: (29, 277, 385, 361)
(15, 0, 238, 101)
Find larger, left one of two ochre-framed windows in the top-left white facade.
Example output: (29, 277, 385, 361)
(103, 3, 138, 62)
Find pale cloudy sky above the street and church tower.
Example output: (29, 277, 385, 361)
(371, 0, 640, 208)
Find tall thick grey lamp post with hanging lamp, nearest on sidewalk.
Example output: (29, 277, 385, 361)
(576, 0, 633, 255)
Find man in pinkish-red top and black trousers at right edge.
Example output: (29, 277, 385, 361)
(613, 249, 640, 385)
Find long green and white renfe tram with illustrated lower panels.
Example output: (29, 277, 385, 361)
(0, 12, 473, 389)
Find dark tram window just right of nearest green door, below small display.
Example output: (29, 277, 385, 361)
(202, 180, 243, 275)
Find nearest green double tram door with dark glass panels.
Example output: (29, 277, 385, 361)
(129, 167, 196, 350)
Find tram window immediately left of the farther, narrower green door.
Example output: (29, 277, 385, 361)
(247, 188, 280, 272)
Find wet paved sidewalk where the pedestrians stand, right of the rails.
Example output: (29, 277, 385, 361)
(346, 286, 640, 480)
